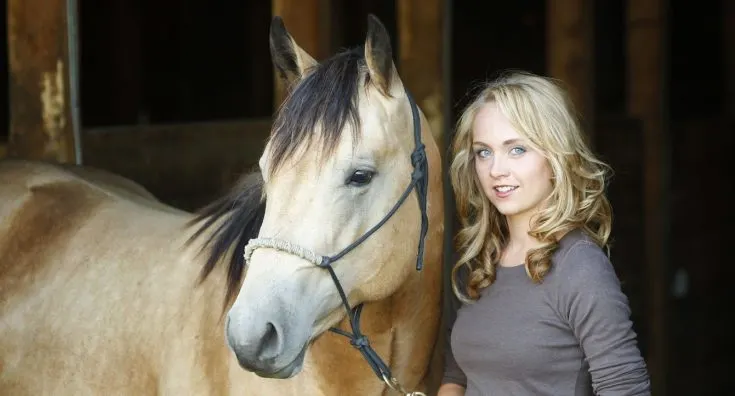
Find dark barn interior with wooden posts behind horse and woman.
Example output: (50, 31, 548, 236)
(0, 0, 735, 396)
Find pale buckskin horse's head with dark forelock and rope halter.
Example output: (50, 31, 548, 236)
(226, 16, 430, 378)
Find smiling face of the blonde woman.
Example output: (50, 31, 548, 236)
(472, 102, 553, 222)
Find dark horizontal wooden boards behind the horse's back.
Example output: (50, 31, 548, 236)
(83, 120, 271, 209)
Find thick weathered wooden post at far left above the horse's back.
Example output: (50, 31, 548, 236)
(8, 0, 76, 163)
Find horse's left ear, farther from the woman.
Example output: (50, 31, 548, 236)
(270, 16, 318, 84)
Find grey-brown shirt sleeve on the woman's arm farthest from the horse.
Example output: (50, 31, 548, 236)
(559, 241, 651, 396)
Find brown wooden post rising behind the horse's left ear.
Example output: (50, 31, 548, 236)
(271, 0, 332, 108)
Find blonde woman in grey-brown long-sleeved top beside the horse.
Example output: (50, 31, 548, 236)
(439, 73, 650, 396)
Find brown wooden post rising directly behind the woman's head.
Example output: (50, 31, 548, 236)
(546, 0, 595, 146)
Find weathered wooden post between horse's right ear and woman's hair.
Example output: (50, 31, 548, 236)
(397, 0, 448, 152)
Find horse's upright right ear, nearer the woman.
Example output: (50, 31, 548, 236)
(365, 14, 402, 96)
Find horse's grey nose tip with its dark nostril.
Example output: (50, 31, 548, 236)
(225, 315, 284, 372)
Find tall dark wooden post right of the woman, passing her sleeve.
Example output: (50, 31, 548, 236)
(626, 0, 670, 395)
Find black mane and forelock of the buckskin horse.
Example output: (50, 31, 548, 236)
(191, 47, 369, 305)
